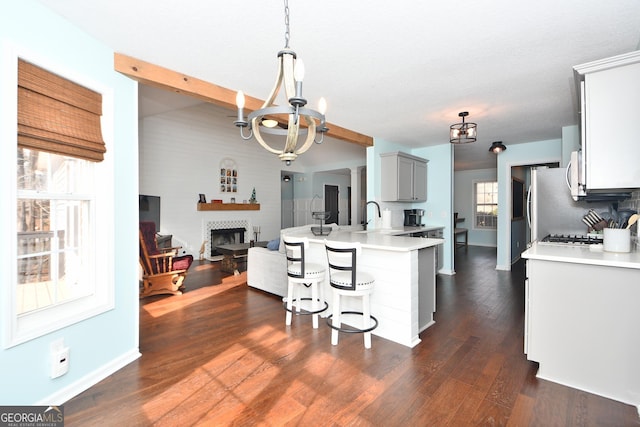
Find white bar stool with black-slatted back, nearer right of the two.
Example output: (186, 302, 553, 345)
(324, 240, 378, 348)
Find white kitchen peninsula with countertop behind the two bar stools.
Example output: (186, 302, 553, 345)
(282, 227, 444, 347)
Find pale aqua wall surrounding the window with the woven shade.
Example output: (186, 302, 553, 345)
(0, 0, 139, 405)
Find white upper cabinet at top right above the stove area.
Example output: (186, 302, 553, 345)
(574, 51, 640, 191)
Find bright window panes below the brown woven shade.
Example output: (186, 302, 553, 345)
(16, 147, 95, 316)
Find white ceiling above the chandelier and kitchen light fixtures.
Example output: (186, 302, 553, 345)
(40, 0, 640, 170)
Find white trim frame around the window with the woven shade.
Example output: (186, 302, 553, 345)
(0, 43, 115, 348)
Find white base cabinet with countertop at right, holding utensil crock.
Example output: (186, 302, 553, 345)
(522, 243, 640, 407)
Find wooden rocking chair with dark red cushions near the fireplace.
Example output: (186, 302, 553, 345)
(139, 221, 193, 297)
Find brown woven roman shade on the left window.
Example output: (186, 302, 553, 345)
(18, 59, 106, 162)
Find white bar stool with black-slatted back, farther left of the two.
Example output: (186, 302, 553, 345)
(282, 236, 329, 329)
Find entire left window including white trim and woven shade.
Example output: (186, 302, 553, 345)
(0, 51, 114, 348)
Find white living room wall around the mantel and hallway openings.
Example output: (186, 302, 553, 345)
(140, 104, 365, 252)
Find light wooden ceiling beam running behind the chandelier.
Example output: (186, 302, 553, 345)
(113, 53, 373, 147)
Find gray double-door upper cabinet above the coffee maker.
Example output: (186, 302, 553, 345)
(380, 151, 428, 202)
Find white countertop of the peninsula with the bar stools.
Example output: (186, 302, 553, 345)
(282, 226, 444, 252)
